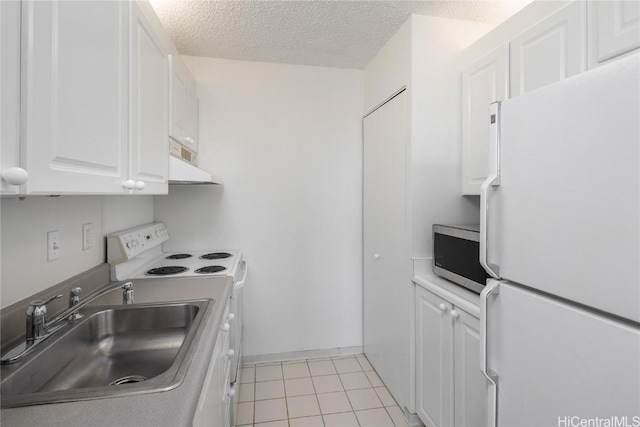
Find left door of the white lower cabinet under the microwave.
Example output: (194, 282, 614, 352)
(416, 286, 456, 427)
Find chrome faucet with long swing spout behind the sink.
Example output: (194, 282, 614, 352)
(0, 282, 133, 365)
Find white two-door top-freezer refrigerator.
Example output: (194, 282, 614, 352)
(480, 54, 640, 427)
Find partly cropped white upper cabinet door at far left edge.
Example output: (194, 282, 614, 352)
(0, 0, 20, 195)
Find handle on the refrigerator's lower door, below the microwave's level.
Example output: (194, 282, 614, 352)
(480, 279, 500, 427)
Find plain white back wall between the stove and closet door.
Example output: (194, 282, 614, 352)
(155, 57, 363, 356)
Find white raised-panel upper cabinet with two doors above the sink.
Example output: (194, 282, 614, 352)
(15, 0, 169, 194)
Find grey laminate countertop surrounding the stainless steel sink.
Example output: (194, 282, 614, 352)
(0, 277, 233, 427)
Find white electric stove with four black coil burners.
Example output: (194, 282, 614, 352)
(107, 223, 247, 425)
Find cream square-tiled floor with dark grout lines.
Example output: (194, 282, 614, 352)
(236, 355, 406, 427)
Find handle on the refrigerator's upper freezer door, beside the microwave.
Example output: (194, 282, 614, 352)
(480, 101, 500, 279)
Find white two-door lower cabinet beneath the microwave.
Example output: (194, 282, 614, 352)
(415, 285, 487, 427)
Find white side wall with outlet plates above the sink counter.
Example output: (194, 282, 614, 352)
(0, 196, 153, 307)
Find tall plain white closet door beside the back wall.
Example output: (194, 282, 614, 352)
(363, 92, 411, 408)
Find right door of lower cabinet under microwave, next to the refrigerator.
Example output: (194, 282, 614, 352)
(449, 307, 487, 427)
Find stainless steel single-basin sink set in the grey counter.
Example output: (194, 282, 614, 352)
(0, 300, 213, 408)
